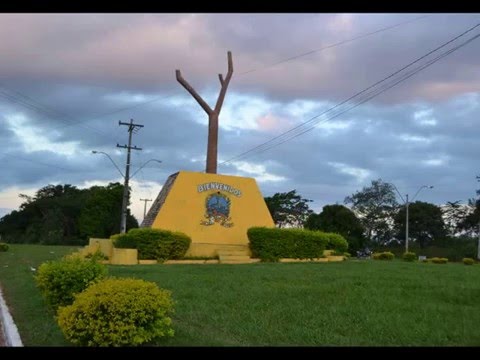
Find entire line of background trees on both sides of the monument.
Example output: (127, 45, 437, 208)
(0, 179, 480, 253)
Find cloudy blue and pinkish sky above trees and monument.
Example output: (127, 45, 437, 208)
(0, 13, 480, 221)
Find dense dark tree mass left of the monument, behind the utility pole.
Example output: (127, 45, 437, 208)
(0, 183, 138, 245)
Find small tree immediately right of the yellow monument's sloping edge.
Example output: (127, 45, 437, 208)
(265, 190, 313, 228)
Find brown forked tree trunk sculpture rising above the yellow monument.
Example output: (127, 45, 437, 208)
(175, 51, 233, 174)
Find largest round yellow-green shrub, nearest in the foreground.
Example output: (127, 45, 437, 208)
(57, 278, 174, 346)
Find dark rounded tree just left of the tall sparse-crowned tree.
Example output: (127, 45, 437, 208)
(305, 204, 365, 253)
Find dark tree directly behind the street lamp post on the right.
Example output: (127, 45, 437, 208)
(394, 201, 447, 249)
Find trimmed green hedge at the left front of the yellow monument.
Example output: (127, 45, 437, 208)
(113, 228, 192, 261)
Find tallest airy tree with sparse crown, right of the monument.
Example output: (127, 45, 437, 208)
(345, 179, 398, 244)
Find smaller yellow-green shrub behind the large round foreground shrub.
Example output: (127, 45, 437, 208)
(35, 255, 107, 310)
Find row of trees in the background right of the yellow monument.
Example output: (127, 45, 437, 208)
(265, 179, 480, 251)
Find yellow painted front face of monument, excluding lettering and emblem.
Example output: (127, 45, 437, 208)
(152, 171, 274, 256)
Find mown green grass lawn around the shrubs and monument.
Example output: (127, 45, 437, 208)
(0, 245, 480, 346)
